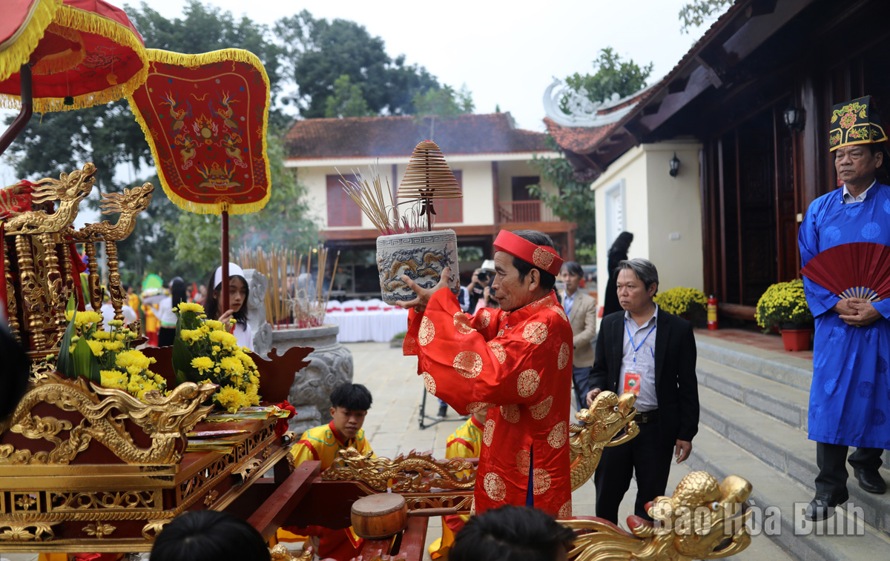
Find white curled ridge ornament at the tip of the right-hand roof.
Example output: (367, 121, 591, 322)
(544, 77, 651, 127)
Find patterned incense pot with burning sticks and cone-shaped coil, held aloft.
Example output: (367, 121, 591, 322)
(340, 140, 462, 304)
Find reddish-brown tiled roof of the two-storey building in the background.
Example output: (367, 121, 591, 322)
(286, 113, 553, 160)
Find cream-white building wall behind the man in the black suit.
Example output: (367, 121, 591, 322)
(591, 142, 704, 302)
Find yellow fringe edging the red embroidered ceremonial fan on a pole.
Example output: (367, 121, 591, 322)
(127, 49, 272, 215)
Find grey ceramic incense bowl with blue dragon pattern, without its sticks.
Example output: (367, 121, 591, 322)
(377, 230, 460, 304)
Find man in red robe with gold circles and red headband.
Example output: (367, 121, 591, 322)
(402, 230, 572, 518)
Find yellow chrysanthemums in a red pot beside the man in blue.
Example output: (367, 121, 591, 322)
(754, 279, 813, 351)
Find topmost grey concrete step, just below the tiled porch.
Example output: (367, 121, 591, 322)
(696, 357, 810, 430)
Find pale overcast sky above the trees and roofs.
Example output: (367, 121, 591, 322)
(121, 0, 704, 132)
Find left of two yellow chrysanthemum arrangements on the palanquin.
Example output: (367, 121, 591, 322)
(58, 311, 167, 399)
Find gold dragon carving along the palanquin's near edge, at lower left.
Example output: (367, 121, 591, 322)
(0, 375, 216, 465)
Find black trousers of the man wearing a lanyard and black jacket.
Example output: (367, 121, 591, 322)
(594, 421, 676, 524)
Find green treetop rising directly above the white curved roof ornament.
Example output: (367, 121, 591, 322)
(560, 47, 652, 110)
